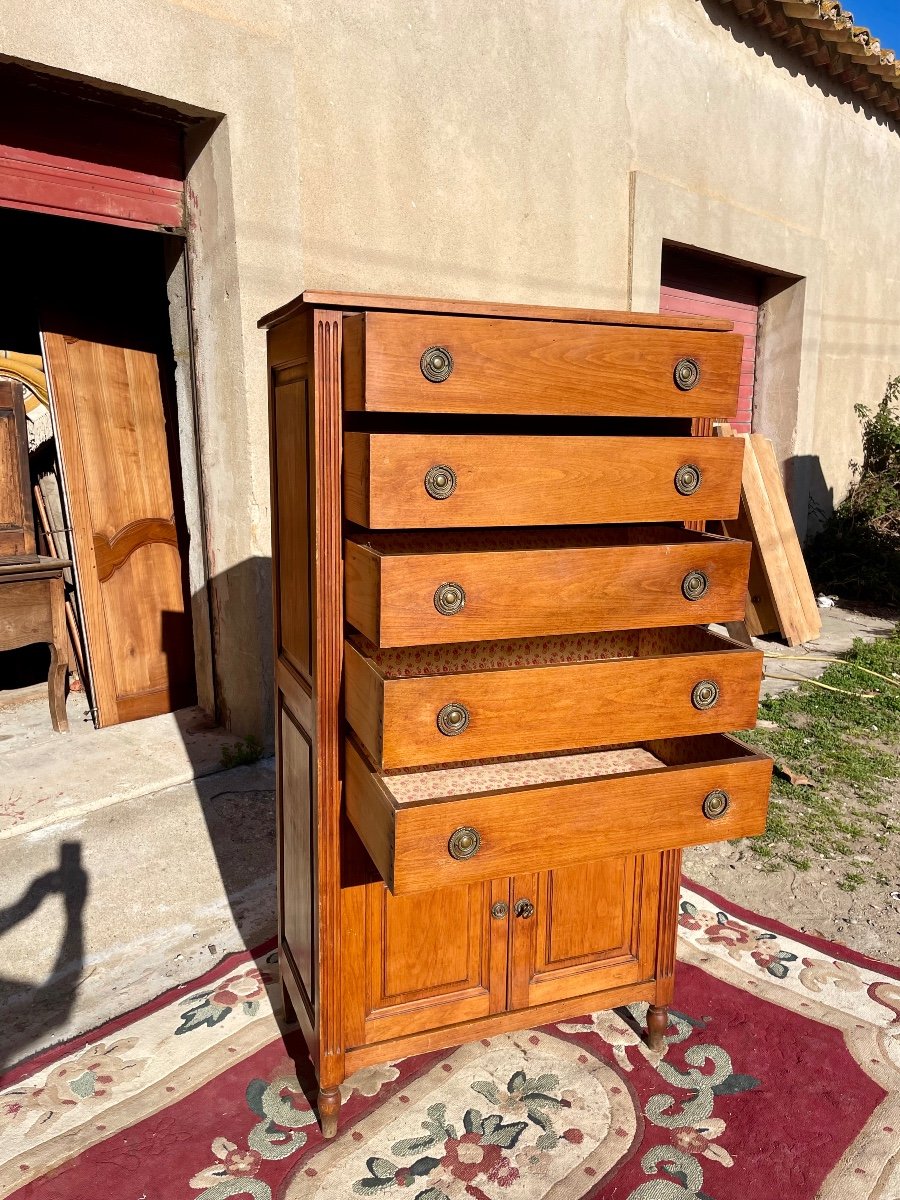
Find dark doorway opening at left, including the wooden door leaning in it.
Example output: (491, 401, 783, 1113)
(0, 209, 197, 726)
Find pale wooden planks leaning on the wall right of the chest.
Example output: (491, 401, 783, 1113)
(716, 422, 822, 646)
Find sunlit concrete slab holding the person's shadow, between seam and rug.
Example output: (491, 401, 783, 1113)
(0, 760, 275, 1064)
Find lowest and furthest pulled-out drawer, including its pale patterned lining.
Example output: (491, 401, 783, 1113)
(344, 734, 772, 895)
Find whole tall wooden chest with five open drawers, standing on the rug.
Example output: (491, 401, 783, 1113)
(260, 293, 772, 1136)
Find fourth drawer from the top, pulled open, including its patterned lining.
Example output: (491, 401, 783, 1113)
(344, 626, 762, 770)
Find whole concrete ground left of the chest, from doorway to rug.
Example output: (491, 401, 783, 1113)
(0, 686, 275, 1066)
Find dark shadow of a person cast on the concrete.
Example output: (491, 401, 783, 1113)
(0, 841, 89, 1072)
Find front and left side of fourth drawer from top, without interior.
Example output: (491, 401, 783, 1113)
(344, 646, 762, 770)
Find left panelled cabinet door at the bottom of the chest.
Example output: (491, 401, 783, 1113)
(343, 864, 510, 1045)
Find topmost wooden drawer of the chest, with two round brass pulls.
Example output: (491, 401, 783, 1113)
(343, 312, 743, 418)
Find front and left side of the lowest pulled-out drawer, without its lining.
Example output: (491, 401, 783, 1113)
(346, 737, 772, 894)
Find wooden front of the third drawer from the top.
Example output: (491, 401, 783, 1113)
(346, 538, 750, 647)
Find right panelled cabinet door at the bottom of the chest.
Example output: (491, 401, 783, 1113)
(510, 853, 661, 1008)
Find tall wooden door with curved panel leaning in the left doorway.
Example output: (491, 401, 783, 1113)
(43, 334, 196, 725)
